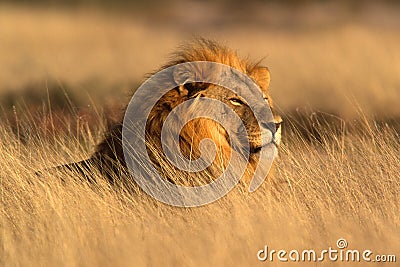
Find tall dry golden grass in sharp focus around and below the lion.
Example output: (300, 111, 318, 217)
(0, 112, 400, 266)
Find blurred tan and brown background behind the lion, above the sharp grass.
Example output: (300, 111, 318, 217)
(0, 0, 400, 133)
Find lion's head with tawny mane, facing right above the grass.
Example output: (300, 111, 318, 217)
(136, 40, 282, 185)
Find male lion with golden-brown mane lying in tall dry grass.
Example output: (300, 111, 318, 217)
(56, 39, 282, 189)
